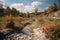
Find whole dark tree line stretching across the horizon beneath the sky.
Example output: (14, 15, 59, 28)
(0, 3, 60, 18)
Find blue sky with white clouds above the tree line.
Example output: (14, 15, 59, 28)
(1, 0, 60, 12)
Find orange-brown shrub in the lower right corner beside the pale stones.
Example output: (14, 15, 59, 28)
(43, 21, 60, 40)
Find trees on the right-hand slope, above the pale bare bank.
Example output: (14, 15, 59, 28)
(44, 3, 60, 15)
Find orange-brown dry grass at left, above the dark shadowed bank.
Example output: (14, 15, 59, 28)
(0, 16, 27, 29)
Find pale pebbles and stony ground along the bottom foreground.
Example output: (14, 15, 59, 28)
(3, 28, 49, 40)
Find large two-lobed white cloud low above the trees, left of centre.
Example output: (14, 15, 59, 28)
(10, 3, 35, 12)
